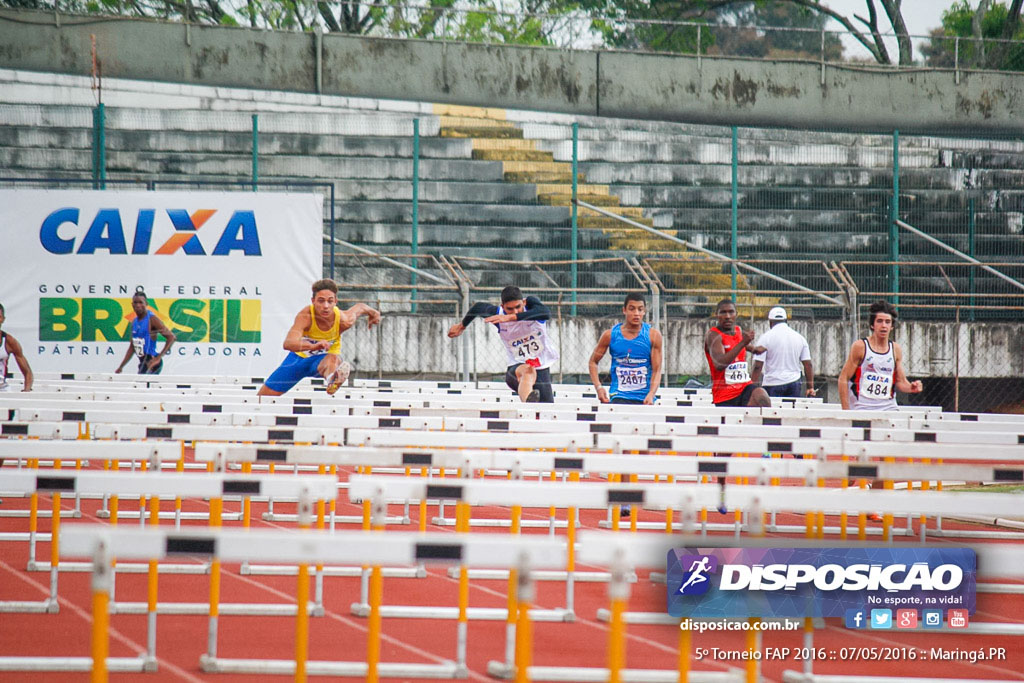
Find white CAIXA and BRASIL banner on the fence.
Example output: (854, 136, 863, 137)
(0, 189, 324, 375)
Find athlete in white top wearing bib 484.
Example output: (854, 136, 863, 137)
(839, 301, 924, 411)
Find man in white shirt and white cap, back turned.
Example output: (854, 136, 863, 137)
(751, 306, 815, 398)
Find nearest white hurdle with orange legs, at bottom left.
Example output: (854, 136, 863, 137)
(58, 524, 566, 681)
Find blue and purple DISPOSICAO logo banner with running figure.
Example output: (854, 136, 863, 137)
(667, 547, 977, 618)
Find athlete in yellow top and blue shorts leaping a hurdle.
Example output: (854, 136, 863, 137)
(258, 280, 381, 396)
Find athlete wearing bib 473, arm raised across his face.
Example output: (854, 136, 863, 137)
(449, 285, 558, 403)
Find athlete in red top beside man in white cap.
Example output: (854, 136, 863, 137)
(705, 299, 771, 408)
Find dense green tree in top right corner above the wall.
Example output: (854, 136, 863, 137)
(922, 0, 1024, 71)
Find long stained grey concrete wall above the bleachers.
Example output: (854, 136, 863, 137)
(0, 10, 1024, 133)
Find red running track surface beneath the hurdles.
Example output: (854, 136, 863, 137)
(0, 462, 1024, 683)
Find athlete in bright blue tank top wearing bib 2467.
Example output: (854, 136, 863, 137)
(590, 294, 662, 405)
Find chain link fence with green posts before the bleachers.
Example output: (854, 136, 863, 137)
(0, 90, 1024, 410)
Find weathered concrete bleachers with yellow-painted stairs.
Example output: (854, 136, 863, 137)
(0, 71, 1024, 305)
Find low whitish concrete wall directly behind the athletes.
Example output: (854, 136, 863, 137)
(342, 314, 1024, 380)
